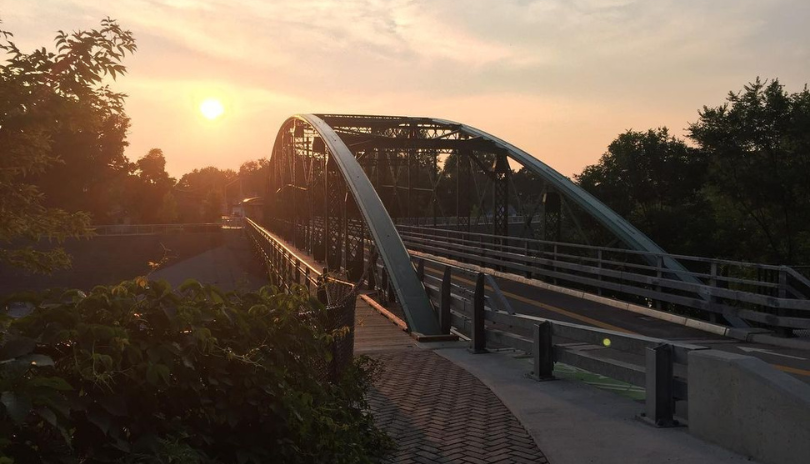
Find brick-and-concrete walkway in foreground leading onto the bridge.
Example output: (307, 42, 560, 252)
(355, 299, 755, 464)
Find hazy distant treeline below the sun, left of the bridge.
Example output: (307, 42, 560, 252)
(33, 145, 267, 224)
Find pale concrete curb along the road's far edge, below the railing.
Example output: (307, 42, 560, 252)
(410, 251, 810, 350)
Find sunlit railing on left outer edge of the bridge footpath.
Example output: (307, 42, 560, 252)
(244, 218, 357, 381)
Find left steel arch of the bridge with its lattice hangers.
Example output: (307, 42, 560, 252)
(270, 114, 440, 335)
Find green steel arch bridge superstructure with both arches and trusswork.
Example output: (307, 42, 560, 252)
(266, 114, 684, 334)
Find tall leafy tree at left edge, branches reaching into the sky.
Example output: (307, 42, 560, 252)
(0, 18, 136, 271)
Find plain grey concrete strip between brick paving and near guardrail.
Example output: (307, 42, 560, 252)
(434, 346, 755, 464)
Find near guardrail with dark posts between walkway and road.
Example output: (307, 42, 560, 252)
(414, 254, 708, 427)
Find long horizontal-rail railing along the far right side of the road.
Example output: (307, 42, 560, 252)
(398, 225, 810, 330)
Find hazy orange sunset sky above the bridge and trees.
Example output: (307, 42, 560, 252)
(0, 0, 810, 176)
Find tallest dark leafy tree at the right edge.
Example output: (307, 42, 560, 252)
(689, 78, 810, 264)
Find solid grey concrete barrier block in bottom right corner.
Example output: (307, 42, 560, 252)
(688, 350, 810, 464)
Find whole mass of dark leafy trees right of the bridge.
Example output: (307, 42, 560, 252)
(575, 78, 810, 264)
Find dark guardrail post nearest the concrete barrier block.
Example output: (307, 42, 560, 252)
(645, 344, 678, 427)
